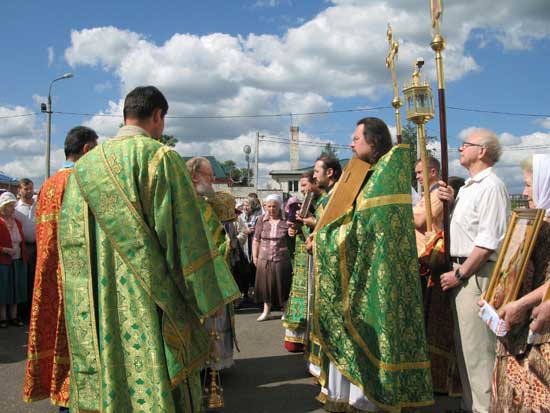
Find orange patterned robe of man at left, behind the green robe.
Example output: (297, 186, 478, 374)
(23, 168, 72, 407)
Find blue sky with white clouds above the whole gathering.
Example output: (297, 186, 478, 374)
(0, 0, 550, 192)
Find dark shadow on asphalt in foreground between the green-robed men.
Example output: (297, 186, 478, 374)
(222, 354, 320, 413)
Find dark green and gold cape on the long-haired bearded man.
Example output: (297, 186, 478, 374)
(313, 145, 433, 410)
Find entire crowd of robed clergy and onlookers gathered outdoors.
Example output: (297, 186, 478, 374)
(0, 86, 550, 413)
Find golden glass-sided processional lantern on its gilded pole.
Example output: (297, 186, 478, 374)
(403, 58, 435, 232)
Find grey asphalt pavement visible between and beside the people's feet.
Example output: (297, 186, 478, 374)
(0, 309, 466, 413)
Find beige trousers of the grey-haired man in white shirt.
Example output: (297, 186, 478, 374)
(452, 261, 496, 413)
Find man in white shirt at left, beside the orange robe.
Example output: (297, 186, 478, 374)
(15, 178, 36, 319)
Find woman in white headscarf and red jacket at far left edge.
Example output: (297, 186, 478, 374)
(0, 192, 27, 328)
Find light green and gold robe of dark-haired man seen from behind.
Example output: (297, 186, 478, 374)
(59, 136, 239, 413)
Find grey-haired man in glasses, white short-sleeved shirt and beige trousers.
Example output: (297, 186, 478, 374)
(438, 129, 510, 413)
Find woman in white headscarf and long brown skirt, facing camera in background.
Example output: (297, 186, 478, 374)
(252, 194, 292, 321)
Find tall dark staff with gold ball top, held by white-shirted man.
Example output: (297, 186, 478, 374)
(430, 0, 451, 269)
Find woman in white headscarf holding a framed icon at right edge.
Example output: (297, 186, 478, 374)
(491, 155, 550, 413)
